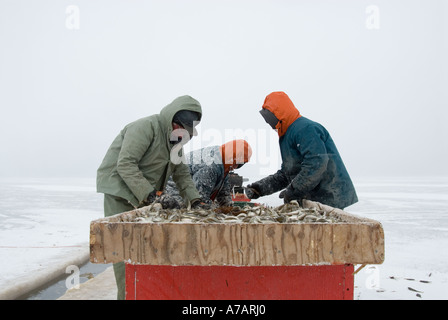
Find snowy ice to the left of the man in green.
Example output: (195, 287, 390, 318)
(0, 179, 103, 297)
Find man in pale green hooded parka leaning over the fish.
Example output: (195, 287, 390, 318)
(97, 96, 202, 300)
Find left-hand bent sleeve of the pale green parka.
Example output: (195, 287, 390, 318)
(117, 123, 154, 203)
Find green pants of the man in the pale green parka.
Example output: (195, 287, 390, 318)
(104, 194, 134, 300)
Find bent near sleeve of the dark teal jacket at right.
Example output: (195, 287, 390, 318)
(289, 127, 329, 196)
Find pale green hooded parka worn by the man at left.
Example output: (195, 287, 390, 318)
(96, 96, 202, 207)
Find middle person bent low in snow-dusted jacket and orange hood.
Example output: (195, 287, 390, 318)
(160, 140, 252, 209)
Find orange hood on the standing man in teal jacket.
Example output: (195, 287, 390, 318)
(262, 91, 301, 137)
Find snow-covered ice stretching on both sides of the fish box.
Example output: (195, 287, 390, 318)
(0, 177, 448, 300)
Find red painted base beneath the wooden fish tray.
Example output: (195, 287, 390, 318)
(126, 264, 354, 300)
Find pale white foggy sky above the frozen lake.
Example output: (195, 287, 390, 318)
(0, 0, 448, 179)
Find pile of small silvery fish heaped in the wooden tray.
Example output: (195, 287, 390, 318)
(135, 201, 341, 223)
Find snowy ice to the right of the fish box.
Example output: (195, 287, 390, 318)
(257, 177, 448, 300)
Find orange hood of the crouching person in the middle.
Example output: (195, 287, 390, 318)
(219, 139, 252, 174)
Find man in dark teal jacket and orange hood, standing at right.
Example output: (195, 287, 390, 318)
(246, 92, 358, 209)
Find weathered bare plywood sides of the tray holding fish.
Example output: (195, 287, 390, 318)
(90, 201, 384, 266)
